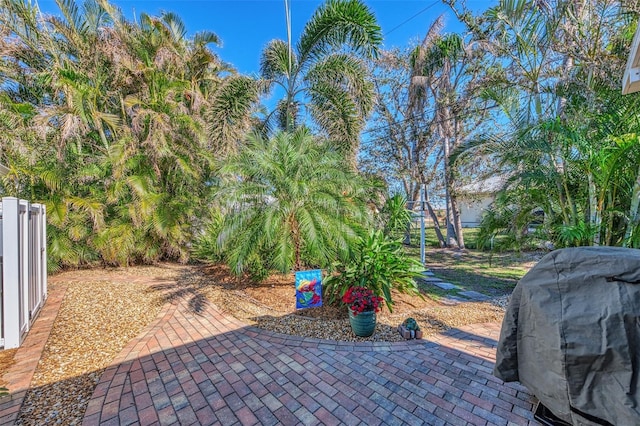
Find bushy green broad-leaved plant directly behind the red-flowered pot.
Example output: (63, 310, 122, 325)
(325, 230, 422, 312)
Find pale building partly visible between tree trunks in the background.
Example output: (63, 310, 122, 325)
(458, 176, 505, 228)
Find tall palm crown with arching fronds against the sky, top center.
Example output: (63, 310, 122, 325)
(260, 0, 382, 163)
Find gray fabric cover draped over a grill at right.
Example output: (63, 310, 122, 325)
(494, 247, 640, 425)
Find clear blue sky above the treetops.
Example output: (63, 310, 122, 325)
(38, 0, 497, 74)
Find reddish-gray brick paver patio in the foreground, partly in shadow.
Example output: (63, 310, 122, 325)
(0, 276, 537, 426)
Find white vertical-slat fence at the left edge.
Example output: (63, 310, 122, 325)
(0, 197, 47, 349)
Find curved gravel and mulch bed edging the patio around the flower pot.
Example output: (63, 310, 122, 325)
(198, 267, 504, 342)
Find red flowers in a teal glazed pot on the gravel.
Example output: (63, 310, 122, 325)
(342, 286, 384, 337)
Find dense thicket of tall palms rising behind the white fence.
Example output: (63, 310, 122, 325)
(0, 0, 258, 265)
